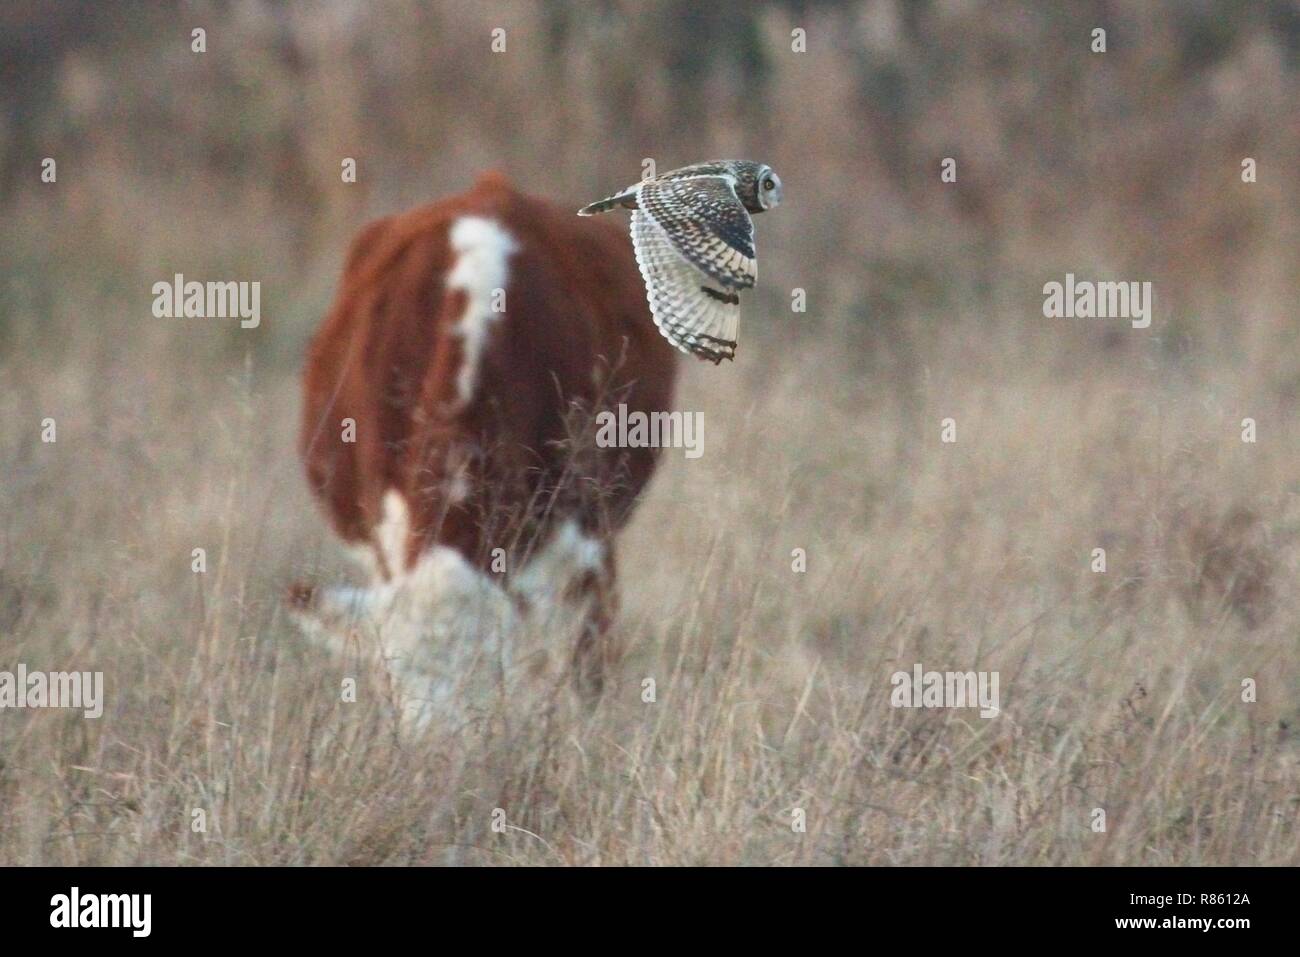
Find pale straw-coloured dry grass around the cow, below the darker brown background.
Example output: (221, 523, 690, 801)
(0, 310, 1300, 863)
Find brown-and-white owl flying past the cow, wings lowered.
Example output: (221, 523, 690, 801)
(577, 160, 781, 365)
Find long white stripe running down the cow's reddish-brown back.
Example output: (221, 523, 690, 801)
(447, 216, 519, 404)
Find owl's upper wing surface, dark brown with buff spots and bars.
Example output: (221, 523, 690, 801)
(637, 176, 758, 291)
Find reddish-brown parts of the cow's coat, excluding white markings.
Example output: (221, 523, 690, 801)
(299, 173, 676, 681)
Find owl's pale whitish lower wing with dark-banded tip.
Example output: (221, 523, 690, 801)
(632, 209, 740, 365)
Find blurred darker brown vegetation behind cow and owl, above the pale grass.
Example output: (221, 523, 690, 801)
(0, 0, 1300, 379)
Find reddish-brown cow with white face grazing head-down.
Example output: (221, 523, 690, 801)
(293, 173, 676, 712)
